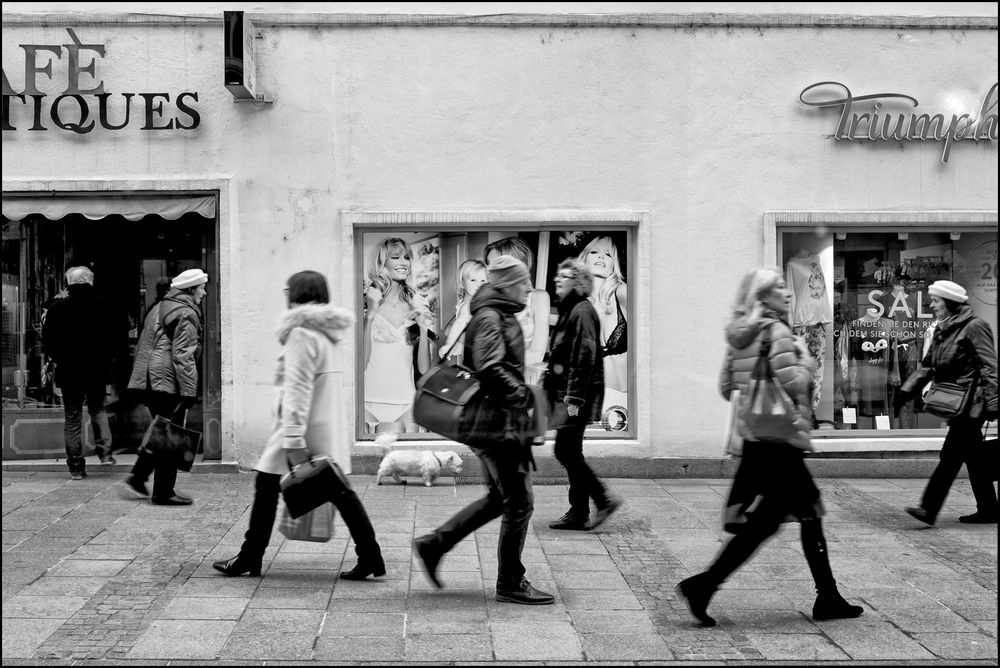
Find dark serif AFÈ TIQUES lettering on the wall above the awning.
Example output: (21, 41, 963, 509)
(3, 28, 201, 135)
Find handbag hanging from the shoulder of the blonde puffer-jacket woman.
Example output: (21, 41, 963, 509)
(737, 329, 807, 443)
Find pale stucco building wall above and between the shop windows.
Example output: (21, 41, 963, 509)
(3, 14, 997, 463)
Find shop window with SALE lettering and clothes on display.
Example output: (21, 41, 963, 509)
(779, 228, 997, 431)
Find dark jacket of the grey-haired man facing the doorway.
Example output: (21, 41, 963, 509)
(42, 283, 128, 390)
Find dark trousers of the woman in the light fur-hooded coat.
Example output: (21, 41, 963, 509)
(240, 464, 382, 563)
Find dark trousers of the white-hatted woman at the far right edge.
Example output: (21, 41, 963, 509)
(920, 418, 997, 520)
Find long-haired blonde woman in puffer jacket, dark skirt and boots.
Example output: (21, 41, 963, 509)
(677, 268, 864, 626)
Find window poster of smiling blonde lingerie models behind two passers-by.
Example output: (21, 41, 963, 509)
(357, 229, 634, 439)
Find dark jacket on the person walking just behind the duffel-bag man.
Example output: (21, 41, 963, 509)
(544, 292, 604, 422)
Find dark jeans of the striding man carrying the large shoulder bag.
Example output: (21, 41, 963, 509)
(431, 441, 535, 582)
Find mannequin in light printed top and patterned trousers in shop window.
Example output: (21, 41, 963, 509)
(785, 246, 833, 416)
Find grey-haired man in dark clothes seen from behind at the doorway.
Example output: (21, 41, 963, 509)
(42, 266, 128, 480)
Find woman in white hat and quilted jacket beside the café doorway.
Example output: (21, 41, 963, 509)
(124, 269, 208, 506)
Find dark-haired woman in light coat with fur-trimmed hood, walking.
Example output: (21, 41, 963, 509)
(213, 271, 385, 580)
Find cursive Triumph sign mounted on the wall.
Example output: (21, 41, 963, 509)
(799, 81, 998, 163)
